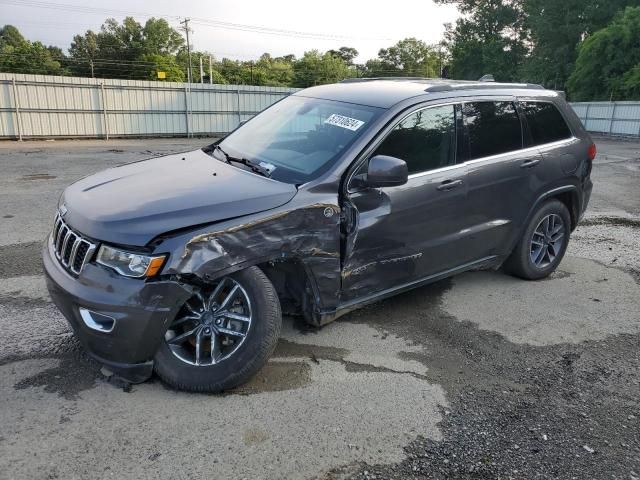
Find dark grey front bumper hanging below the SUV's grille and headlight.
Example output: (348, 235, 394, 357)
(42, 241, 192, 383)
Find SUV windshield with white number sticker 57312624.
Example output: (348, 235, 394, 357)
(219, 96, 382, 185)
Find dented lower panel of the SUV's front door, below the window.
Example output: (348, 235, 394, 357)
(342, 165, 467, 301)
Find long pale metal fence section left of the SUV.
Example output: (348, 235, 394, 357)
(0, 73, 297, 139)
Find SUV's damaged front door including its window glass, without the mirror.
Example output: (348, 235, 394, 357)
(342, 105, 467, 301)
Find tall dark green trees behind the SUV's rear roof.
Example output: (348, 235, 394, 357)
(435, 0, 638, 89)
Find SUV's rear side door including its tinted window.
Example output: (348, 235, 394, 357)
(461, 97, 542, 258)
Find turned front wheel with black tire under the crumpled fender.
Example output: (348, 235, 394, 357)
(154, 267, 282, 392)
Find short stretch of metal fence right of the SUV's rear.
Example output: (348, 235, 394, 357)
(571, 102, 640, 137)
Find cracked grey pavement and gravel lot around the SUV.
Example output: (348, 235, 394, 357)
(0, 139, 640, 480)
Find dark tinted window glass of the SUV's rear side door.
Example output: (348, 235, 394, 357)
(462, 102, 522, 160)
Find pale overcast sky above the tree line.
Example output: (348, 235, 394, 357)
(0, 0, 458, 62)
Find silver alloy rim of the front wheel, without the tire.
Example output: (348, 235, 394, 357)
(165, 277, 252, 366)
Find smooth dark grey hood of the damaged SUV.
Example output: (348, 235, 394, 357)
(62, 150, 297, 246)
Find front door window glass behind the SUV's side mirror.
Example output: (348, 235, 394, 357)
(375, 105, 456, 173)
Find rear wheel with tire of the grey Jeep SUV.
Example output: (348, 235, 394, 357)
(505, 200, 571, 280)
